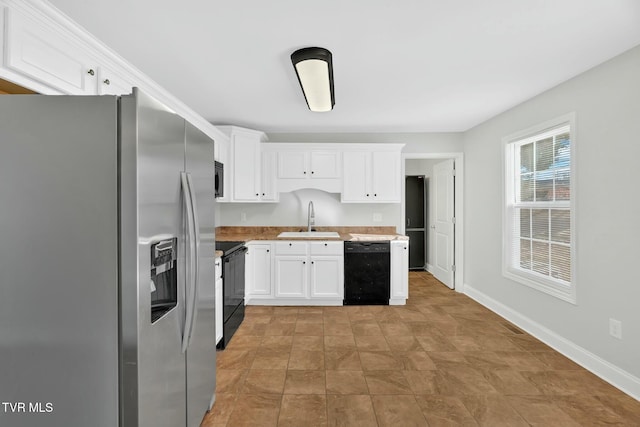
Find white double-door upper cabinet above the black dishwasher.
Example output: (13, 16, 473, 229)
(342, 144, 402, 203)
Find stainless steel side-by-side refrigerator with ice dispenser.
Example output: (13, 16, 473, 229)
(0, 89, 215, 427)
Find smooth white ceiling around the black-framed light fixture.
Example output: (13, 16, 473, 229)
(51, 0, 640, 132)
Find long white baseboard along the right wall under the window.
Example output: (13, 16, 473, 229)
(463, 283, 640, 400)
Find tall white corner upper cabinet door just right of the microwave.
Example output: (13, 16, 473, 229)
(231, 133, 261, 202)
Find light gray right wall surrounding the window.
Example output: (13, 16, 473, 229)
(464, 43, 640, 378)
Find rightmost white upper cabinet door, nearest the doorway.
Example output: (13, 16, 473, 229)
(371, 151, 401, 202)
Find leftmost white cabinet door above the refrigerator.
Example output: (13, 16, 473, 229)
(6, 10, 97, 95)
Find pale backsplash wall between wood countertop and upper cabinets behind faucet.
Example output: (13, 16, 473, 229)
(216, 189, 400, 231)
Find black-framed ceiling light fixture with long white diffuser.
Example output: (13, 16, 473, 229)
(291, 47, 336, 112)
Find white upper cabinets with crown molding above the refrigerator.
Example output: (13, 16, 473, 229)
(0, 0, 222, 146)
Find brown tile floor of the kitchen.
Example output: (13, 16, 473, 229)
(202, 272, 640, 427)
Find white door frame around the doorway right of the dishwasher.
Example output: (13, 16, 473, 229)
(398, 152, 464, 293)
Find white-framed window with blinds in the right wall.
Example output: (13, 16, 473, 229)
(503, 115, 575, 302)
